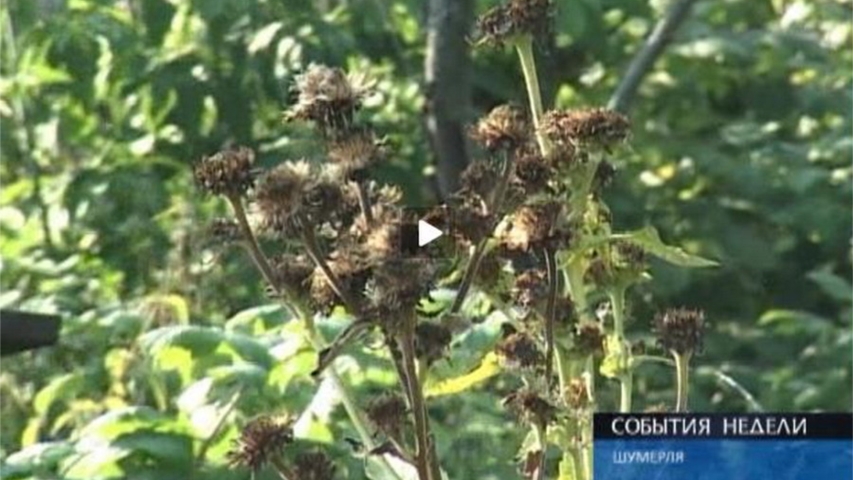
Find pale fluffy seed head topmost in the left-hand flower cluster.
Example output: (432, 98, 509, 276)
(285, 64, 367, 136)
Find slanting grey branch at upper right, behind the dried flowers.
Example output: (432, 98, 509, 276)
(607, 0, 695, 113)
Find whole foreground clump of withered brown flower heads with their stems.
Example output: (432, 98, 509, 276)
(198, 0, 704, 480)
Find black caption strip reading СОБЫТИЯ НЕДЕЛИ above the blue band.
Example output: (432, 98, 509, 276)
(593, 413, 853, 440)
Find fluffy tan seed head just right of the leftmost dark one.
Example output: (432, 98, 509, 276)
(255, 161, 311, 232)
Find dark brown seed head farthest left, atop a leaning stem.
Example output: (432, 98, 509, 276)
(193, 147, 255, 197)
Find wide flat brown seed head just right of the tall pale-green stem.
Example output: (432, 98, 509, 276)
(539, 108, 629, 147)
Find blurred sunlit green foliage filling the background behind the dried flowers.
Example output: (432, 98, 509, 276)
(0, 0, 853, 479)
